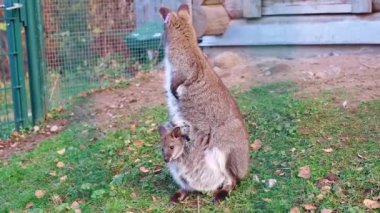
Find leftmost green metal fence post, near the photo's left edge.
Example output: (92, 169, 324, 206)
(4, 0, 28, 130)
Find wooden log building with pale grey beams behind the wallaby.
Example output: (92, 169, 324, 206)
(135, 0, 380, 54)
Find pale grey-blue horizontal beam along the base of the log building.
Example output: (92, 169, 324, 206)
(200, 13, 380, 47)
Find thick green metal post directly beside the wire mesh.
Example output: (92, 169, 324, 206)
(25, 0, 45, 124)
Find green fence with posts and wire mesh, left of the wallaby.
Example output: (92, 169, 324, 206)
(0, 0, 163, 138)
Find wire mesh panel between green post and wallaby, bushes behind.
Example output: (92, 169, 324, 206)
(42, 0, 163, 107)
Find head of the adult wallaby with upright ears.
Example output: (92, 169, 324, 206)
(159, 4, 197, 48)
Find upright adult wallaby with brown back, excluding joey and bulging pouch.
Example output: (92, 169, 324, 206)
(160, 5, 249, 199)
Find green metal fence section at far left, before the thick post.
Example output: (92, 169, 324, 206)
(0, 0, 28, 138)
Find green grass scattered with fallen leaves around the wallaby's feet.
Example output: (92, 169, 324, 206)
(0, 83, 380, 212)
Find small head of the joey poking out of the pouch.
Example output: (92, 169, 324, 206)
(158, 126, 185, 162)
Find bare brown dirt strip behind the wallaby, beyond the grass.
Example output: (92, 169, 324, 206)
(0, 54, 380, 160)
